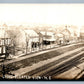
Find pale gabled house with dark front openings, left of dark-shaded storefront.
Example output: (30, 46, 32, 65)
(24, 30, 39, 50)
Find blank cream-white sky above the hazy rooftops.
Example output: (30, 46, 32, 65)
(0, 4, 84, 26)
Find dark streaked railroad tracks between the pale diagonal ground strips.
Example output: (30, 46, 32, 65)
(25, 48, 84, 77)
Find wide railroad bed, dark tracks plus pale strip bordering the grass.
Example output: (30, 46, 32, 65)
(1, 42, 84, 78)
